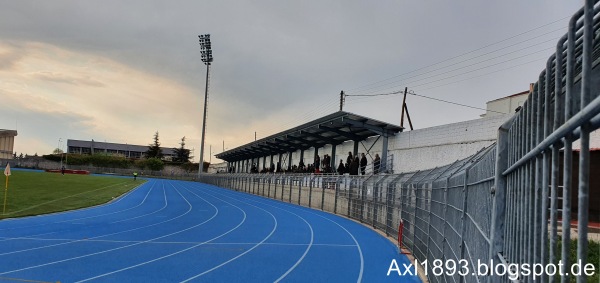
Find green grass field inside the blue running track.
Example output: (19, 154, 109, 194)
(0, 170, 145, 219)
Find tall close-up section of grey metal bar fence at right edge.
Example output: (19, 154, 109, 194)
(490, 0, 600, 282)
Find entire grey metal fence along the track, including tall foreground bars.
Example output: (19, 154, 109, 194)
(200, 0, 600, 282)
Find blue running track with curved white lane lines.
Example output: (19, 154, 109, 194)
(0, 179, 420, 282)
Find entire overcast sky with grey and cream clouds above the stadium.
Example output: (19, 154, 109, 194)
(0, 0, 583, 162)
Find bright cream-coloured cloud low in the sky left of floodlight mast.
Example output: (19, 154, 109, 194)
(0, 43, 201, 159)
